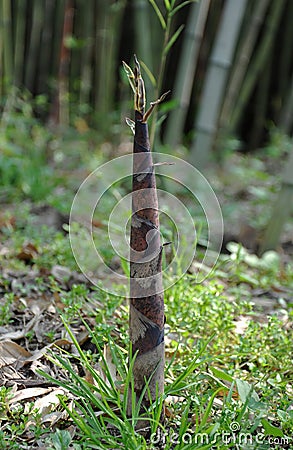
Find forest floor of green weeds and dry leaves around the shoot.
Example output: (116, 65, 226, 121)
(0, 121, 293, 449)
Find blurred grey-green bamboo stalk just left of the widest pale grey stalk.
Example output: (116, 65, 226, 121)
(164, 0, 210, 147)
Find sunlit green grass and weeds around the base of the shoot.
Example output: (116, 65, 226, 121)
(0, 217, 293, 449)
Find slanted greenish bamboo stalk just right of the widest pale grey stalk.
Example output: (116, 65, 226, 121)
(219, 0, 270, 138)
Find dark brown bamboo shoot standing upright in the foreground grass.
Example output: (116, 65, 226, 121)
(124, 59, 165, 429)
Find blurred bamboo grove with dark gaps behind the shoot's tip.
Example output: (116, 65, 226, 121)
(0, 0, 293, 157)
